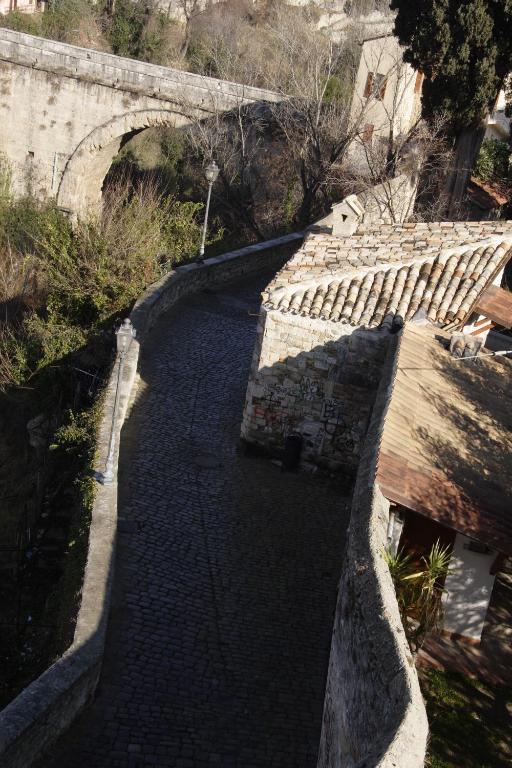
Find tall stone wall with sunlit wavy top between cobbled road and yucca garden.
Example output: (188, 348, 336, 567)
(318, 340, 428, 768)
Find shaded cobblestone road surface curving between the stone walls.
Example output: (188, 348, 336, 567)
(43, 280, 347, 768)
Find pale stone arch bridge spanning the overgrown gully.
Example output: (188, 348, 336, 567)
(0, 29, 280, 215)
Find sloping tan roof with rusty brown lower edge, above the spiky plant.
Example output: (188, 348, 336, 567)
(377, 324, 512, 554)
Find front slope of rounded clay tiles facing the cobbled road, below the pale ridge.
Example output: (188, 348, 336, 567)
(267, 238, 512, 327)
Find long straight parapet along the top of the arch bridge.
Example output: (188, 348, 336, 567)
(0, 28, 283, 102)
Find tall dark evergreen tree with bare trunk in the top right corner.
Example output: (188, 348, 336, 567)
(391, 0, 512, 209)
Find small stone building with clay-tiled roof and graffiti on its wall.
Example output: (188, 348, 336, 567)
(242, 220, 512, 476)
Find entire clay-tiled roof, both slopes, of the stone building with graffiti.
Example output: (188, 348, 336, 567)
(263, 221, 512, 327)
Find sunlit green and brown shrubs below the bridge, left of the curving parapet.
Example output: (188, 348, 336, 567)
(0, 176, 211, 389)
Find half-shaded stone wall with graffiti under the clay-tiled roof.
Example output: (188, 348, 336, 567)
(242, 309, 388, 475)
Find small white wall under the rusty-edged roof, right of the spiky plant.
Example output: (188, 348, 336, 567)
(444, 533, 496, 640)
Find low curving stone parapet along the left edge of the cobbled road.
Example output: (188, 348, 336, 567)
(0, 234, 302, 768)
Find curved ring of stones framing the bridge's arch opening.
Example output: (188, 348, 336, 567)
(57, 109, 196, 217)
